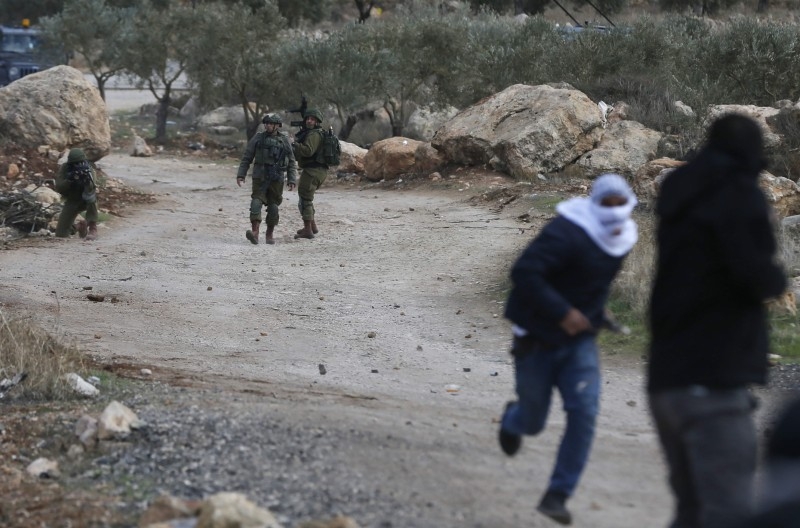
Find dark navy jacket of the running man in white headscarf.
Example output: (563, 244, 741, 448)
(505, 216, 625, 346)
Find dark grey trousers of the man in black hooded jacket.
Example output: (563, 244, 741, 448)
(650, 385, 757, 528)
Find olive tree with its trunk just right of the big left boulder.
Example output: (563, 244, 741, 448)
(121, 2, 198, 143)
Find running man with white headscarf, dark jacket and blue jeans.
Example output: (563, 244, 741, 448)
(499, 174, 638, 524)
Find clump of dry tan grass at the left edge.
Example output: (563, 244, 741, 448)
(0, 311, 89, 400)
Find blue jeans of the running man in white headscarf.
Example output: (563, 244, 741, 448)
(502, 335, 600, 496)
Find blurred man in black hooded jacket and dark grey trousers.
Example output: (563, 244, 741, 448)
(647, 114, 786, 528)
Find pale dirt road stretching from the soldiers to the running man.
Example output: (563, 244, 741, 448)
(0, 155, 671, 528)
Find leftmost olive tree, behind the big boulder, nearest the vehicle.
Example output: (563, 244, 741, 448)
(39, 0, 133, 100)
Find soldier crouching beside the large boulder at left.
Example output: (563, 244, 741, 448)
(55, 148, 97, 240)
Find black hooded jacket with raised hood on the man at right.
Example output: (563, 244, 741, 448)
(648, 115, 786, 392)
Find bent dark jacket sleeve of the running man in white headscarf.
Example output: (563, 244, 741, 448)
(511, 223, 575, 321)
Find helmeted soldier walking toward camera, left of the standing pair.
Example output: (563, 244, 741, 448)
(236, 114, 297, 244)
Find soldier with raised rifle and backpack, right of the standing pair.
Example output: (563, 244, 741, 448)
(293, 108, 328, 238)
